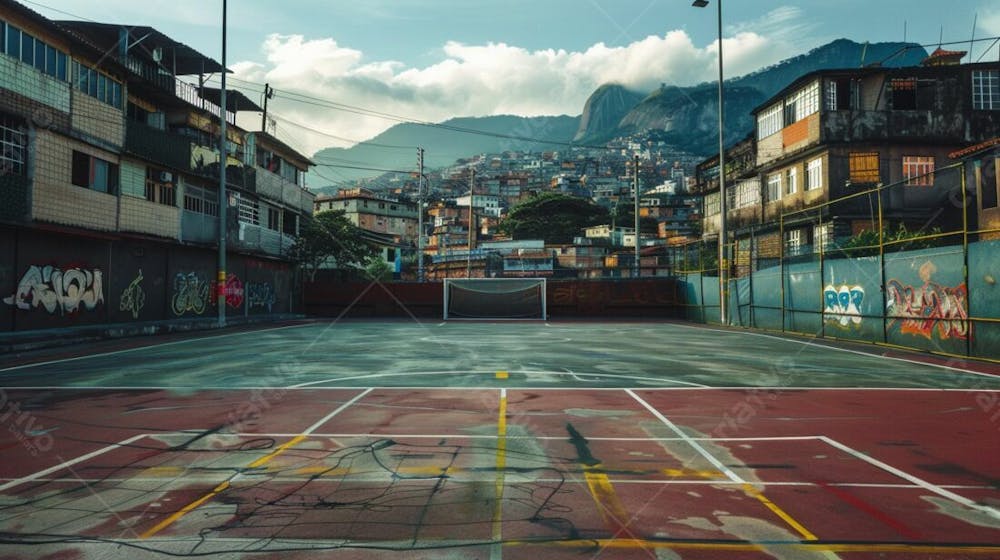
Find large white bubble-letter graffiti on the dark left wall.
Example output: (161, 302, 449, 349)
(3, 265, 104, 314)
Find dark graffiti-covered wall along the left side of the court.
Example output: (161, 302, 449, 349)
(0, 228, 298, 332)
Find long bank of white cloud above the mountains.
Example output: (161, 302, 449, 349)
(238, 24, 801, 153)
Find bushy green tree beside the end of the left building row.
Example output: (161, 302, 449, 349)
(289, 210, 375, 281)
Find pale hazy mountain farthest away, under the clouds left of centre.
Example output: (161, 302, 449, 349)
(309, 115, 580, 186)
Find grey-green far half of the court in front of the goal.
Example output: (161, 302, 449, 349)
(0, 321, 1000, 389)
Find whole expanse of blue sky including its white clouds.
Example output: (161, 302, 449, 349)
(25, 0, 1000, 153)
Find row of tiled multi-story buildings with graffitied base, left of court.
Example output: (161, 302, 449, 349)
(0, 0, 313, 331)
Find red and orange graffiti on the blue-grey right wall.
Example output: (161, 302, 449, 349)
(885, 261, 969, 340)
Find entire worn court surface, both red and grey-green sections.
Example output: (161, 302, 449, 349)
(0, 321, 1000, 560)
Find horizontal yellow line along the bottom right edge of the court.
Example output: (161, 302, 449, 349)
(505, 539, 1000, 556)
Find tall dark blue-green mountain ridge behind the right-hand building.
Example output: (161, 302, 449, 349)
(576, 39, 927, 151)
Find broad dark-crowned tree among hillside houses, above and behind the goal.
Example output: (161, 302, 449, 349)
(499, 193, 610, 243)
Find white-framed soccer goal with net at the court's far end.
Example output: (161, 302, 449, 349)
(444, 278, 547, 321)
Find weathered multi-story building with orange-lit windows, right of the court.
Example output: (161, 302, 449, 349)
(698, 53, 1000, 257)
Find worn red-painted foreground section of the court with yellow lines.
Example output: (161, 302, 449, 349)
(0, 388, 1000, 559)
